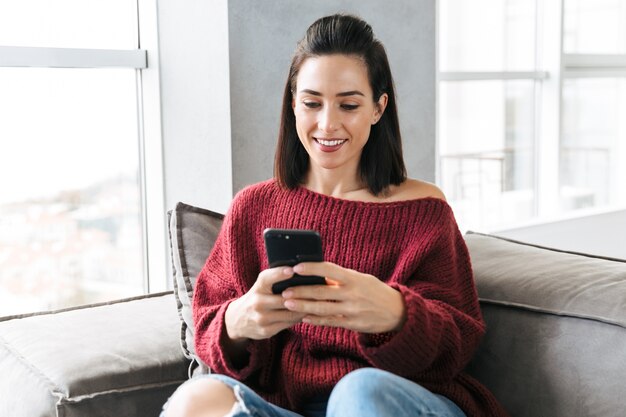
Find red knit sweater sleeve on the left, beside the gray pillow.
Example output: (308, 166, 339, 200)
(188, 193, 271, 381)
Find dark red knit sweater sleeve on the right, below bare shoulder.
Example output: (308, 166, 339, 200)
(357, 212, 485, 382)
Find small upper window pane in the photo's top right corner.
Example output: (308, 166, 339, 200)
(563, 0, 626, 54)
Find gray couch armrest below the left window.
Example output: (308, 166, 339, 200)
(0, 293, 187, 417)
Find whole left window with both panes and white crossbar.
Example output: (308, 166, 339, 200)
(0, 0, 164, 316)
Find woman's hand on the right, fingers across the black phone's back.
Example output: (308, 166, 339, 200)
(282, 262, 406, 333)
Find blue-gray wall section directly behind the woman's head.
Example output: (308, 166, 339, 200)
(228, 0, 435, 191)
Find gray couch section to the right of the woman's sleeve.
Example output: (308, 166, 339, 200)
(465, 232, 626, 417)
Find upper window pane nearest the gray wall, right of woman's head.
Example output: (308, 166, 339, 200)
(439, 0, 535, 71)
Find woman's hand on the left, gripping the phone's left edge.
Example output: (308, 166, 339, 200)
(224, 267, 306, 343)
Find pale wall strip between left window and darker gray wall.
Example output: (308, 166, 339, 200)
(158, 0, 233, 212)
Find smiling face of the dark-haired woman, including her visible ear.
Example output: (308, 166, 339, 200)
(292, 54, 387, 173)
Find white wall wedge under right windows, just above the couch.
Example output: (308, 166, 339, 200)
(493, 210, 626, 259)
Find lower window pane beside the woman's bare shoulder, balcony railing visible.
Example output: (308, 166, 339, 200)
(439, 80, 535, 229)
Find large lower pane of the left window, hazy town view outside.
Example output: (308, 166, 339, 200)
(0, 68, 144, 315)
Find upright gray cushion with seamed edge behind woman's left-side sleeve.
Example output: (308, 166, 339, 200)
(168, 203, 224, 376)
